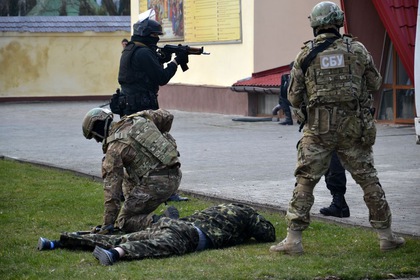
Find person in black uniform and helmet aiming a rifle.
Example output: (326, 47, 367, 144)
(111, 18, 188, 116)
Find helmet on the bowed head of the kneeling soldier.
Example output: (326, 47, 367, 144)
(82, 108, 114, 139)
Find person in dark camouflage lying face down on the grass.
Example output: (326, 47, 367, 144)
(38, 203, 276, 265)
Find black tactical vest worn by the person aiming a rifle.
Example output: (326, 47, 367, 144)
(118, 42, 152, 88)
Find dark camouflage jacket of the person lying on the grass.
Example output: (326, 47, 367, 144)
(180, 203, 276, 248)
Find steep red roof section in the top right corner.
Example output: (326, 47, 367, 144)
(372, 0, 418, 83)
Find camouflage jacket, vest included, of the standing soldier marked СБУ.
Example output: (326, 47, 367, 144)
(288, 33, 382, 137)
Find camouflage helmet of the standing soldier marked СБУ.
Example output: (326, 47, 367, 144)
(309, 1, 344, 29)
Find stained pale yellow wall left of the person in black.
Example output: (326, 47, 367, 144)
(0, 32, 130, 98)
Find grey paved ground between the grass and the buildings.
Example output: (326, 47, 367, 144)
(0, 99, 420, 237)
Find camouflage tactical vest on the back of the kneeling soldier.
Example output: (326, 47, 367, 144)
(107, 117, 178, 178)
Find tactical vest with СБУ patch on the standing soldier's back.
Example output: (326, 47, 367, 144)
(306, 35, 364, 105)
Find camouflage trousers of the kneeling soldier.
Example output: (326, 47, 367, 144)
(115, 168, 182, 232)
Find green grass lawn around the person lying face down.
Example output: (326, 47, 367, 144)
(0, 160, 420, 280)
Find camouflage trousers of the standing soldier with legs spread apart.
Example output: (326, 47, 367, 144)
(286, 131, 391, 230)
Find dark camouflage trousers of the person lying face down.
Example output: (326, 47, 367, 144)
(60, 218, 199, 259)
